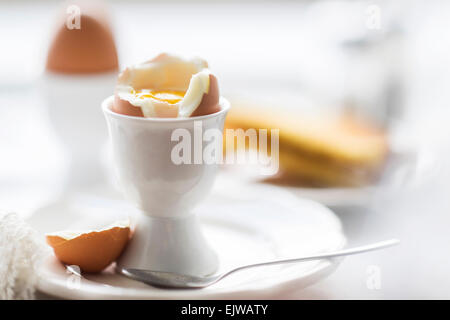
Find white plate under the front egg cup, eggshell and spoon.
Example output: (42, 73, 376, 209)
(29, 175, 346, 299)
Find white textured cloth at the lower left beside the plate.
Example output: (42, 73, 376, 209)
(0, 211, 46, 300)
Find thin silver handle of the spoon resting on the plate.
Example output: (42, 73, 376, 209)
(221, 239, 400, 278)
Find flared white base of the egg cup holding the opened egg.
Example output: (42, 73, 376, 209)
(116, 214, 219, 276)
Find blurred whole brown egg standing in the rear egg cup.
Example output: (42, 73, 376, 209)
(46, 2, 118, 73)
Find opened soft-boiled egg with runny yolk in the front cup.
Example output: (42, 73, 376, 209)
(113, 53, 220, 118)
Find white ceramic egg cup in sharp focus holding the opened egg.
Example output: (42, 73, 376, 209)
(102, 97, 229, 276)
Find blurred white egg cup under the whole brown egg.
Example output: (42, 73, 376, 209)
(39, 72, 117, 193)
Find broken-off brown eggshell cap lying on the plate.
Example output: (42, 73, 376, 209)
(46, 220, 130, 272)
